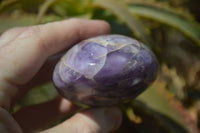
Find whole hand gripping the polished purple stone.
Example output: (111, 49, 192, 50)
(0, 19, 122, 133)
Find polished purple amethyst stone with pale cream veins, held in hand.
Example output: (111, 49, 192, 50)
(53, 35, 159, 106)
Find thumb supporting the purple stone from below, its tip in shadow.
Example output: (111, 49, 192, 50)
(41, 107, 122, 133)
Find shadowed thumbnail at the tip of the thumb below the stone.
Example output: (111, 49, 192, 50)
(105, 107, 122, 131)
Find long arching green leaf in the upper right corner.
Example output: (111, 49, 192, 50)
(129, 4, 200, 46)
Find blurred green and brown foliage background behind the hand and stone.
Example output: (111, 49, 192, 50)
(0, 0, 200, 133)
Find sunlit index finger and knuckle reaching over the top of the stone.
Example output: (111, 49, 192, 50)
(0, 19, 110, 110)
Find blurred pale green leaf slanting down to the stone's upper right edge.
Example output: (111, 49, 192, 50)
(94, 0, 151, 44)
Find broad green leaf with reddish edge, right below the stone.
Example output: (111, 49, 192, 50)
(136, 80, 198, 133)
